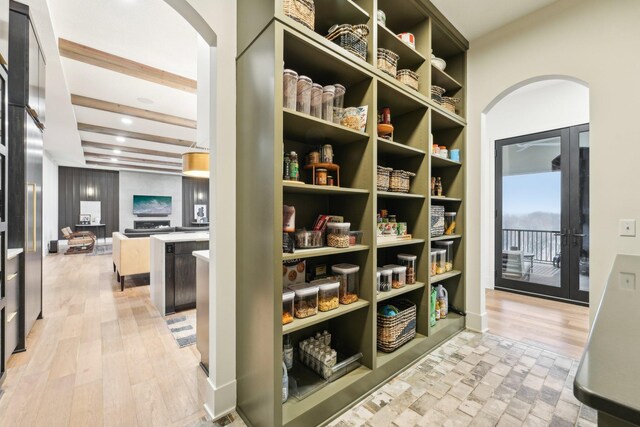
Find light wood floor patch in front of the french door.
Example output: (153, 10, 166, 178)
(486, 289, 589, 360)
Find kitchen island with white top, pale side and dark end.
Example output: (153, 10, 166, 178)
(150, 232, 209, 316)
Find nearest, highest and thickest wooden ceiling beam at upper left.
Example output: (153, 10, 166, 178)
(58, 38, 197, 93)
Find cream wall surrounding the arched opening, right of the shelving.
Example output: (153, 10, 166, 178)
(465, 0, 640, 329)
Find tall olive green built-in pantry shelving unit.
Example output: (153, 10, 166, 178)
(236, 0, 468, 426)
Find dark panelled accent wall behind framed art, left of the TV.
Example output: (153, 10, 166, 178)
(58, 166, 120, 239)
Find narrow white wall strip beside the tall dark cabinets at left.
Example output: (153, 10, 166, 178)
(42, 151, 58, 251)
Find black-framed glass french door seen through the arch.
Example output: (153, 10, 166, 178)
(495, 124, 589, 303)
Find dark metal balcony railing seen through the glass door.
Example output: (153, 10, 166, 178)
(502, 228, 561, 264)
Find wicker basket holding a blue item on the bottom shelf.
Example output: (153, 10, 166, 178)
(377, 299, 416, 353)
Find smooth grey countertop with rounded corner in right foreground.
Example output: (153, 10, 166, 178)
(573, 255, 640, 424)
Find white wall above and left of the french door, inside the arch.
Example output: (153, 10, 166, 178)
(481, 79, 589, 289)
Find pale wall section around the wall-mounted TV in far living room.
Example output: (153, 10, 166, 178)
(119, 171, 182, 232)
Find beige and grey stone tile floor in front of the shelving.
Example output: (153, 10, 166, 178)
(201, 331, 597, 427)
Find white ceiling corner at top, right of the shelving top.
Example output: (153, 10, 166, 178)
(431, 0, 557, 41)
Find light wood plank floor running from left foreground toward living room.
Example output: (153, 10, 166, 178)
(0, 255, 206, 427)
